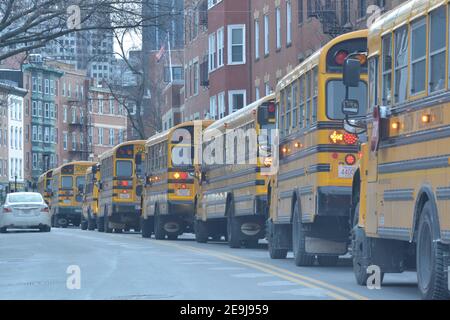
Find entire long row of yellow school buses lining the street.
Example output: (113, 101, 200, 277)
(40, 0, 450, 299)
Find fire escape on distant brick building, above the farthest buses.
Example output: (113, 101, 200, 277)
(68, 95, 92, 161)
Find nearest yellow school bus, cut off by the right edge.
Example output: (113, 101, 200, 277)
(345, 0, 450, 299)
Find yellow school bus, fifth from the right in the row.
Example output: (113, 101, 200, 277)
(97, 140, 145, 233)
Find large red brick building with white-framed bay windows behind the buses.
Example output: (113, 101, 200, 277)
(181, 0, 404, 120)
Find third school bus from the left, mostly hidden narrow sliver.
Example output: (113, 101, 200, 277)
(80, 163, 101, 231)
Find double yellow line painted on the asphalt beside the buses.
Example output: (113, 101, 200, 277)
(155, 241, 354, 300)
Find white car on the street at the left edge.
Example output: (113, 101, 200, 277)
(0, 192, 51, 233)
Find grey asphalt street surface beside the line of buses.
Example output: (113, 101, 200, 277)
(0, 228, 420, 300)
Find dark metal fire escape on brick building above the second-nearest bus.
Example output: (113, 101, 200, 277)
(308, 0, 353, 38)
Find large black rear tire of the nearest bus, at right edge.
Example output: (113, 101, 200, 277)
(416, 202, 449, 300)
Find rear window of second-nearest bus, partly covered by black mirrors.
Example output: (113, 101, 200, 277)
(327, 80, 367, 120)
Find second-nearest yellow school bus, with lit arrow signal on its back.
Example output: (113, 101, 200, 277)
(267, 30, 367, 266)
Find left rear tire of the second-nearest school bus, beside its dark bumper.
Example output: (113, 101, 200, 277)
(292, 202, 314, 267)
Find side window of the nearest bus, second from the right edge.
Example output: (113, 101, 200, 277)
(410, 18, 427, 95)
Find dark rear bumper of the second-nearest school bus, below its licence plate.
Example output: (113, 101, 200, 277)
(317, 187, 352, 217)
